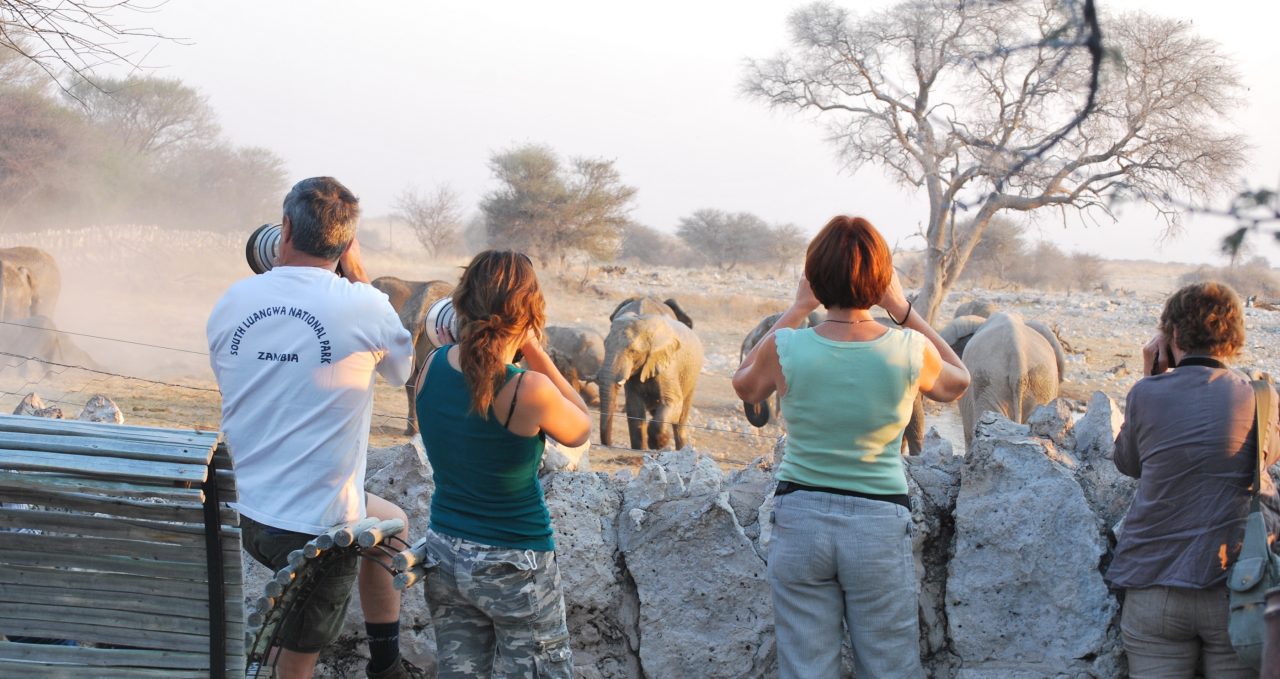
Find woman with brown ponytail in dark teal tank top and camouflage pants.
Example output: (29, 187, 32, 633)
(417, 250, 591, 679)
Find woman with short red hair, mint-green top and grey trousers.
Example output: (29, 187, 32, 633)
(733, 217, 969, 679)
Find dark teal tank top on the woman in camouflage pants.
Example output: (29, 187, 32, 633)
(416, 347, 556, 552)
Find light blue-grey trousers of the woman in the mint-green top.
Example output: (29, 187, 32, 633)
(768, 491, 924, 679)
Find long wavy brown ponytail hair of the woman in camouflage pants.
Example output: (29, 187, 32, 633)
(453, 250, 547, 418)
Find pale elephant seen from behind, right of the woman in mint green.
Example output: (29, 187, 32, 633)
(960, 313, 1065, 448)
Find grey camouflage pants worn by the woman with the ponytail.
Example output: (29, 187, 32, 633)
(425, 530, 573, 679)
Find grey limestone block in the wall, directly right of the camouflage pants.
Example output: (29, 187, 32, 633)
(543, 473, 640, 679)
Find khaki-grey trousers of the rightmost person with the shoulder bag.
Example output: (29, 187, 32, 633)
(1120, 587, 1258, 679)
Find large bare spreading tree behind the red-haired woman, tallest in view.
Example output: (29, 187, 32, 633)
(744, 0, 1244, 320)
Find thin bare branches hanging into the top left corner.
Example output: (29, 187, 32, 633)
(0, 0, 169, 91)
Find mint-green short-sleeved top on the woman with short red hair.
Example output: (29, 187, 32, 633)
(774, 328, 927, 495)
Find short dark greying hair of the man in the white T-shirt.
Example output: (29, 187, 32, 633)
(284, 177, 360, 260)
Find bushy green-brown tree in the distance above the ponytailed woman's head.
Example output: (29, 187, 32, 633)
(480, 145, 636, 269)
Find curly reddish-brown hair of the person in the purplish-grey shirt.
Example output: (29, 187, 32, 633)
(1160, 281, 1244, 359)
